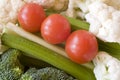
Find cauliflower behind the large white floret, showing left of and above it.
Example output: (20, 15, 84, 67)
(66, 0, 120, 18)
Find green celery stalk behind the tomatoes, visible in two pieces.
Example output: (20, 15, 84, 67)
(66, 17, 120, 59)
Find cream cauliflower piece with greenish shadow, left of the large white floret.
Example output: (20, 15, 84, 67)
(66, 0, 94, 18)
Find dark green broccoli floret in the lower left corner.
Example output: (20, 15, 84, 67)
(0, 49, 23, 80)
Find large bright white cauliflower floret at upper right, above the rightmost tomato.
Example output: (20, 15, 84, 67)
(85, 1, 120, 43)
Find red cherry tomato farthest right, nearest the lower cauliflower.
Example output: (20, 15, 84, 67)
(65, 30, 98, 64)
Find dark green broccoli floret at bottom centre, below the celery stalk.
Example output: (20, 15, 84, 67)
(20, 67, 76, 80)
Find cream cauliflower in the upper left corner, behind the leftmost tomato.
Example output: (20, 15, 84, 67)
(0, 0, 69, 24)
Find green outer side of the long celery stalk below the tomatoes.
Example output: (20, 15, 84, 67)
(2, 33, 95, 80)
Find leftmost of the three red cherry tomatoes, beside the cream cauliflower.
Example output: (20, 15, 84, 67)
(18, 3, 46, 32)
